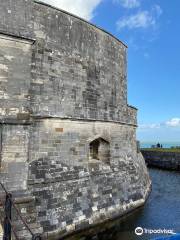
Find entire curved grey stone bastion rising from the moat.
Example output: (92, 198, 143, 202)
(0, 0, 151, 240)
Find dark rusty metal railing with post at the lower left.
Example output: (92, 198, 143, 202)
(0, 182, 42, 240)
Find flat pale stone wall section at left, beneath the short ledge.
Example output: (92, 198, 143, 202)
(0, 34, 32, 121)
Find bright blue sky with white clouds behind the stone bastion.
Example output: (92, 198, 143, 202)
(43, 0, 180, 142)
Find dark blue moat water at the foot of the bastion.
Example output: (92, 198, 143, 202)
(67, 169, 180, 240)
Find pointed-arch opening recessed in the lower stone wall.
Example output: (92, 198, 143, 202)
(90, 138, 110, 164)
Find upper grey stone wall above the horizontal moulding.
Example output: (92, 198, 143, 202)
(0, 0, 136, 124)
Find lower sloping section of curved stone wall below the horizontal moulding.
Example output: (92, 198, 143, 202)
(29, 120, 149, 236)
